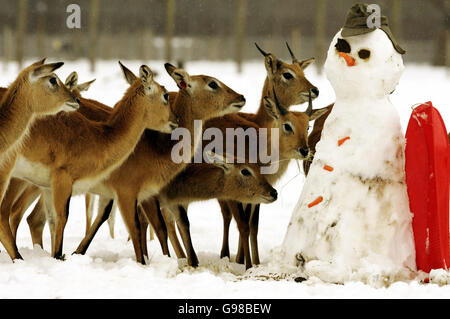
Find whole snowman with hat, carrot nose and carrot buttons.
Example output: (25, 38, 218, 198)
(282, 4, 416, 282)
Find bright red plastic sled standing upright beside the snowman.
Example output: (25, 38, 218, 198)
(405, 102, 450, 273)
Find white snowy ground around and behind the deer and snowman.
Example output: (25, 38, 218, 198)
(0, 59, 450, 299)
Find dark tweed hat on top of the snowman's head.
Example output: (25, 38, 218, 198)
(341, 3, 406, 54)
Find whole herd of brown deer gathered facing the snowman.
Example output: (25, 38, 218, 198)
(0, 45, 331, 269)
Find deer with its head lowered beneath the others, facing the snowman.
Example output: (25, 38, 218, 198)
(147, 154, 278, 266)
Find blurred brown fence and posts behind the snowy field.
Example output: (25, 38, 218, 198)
(0, 0, 450, 68)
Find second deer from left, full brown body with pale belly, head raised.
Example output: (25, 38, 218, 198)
(1, 65, 177, 259)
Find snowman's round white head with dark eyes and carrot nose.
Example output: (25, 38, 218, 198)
(325, 29, 404, 98)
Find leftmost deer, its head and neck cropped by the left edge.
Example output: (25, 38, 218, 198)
(0, 59, 79, 260)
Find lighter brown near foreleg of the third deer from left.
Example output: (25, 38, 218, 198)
(117, 192, 145, 265)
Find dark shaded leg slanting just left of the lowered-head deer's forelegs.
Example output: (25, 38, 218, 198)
(141, 197, 170, 256)
